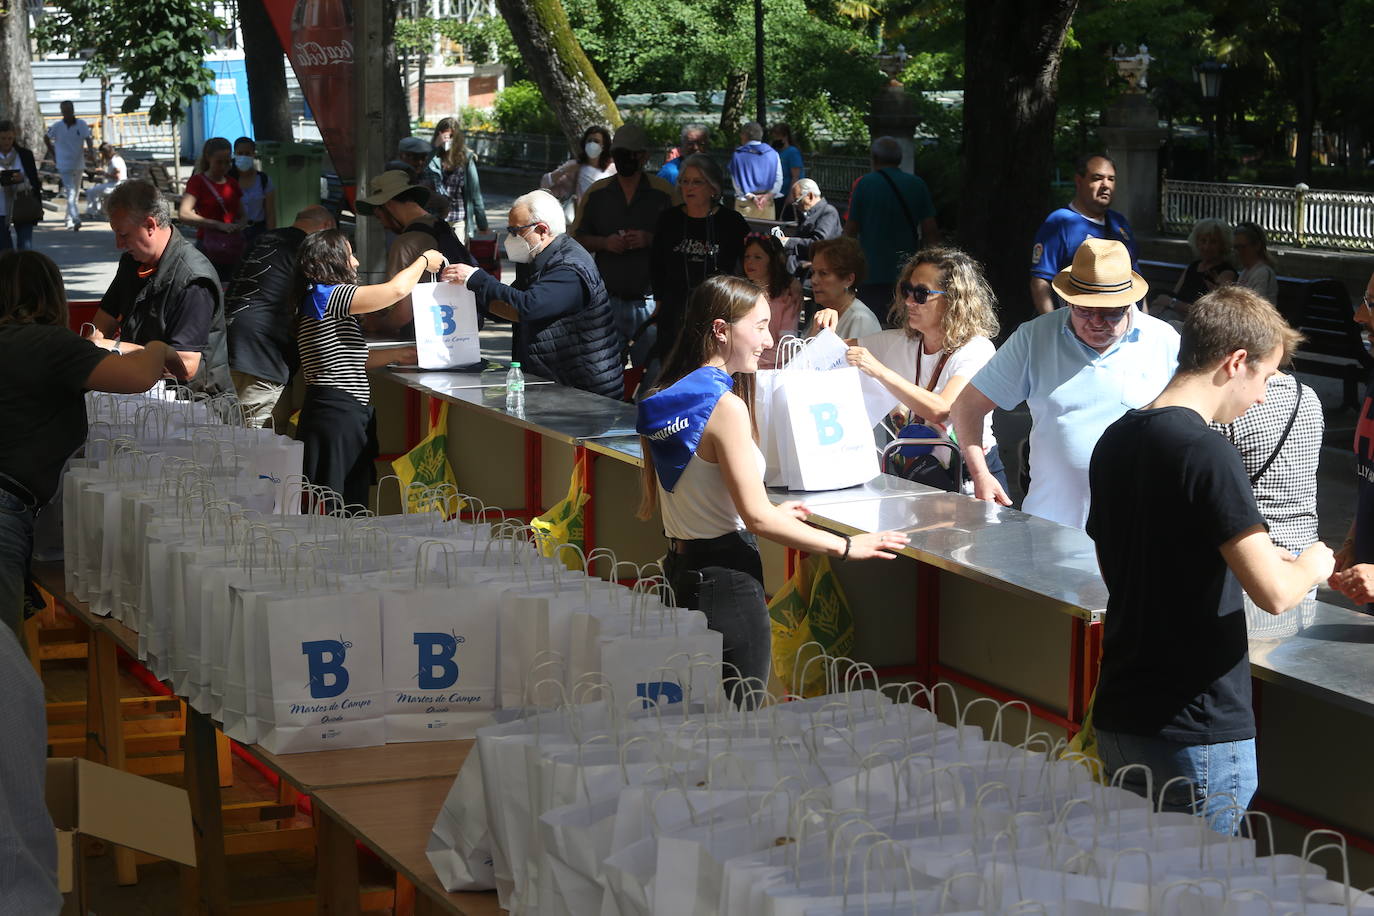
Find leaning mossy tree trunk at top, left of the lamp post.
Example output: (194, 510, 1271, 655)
(496, 0, 621, 150)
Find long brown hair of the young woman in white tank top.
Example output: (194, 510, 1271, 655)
(635, 273, 760, 520)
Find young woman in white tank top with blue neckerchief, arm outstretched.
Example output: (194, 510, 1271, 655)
(638, 276, 908, 688)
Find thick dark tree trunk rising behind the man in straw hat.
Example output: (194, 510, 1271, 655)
(959, 0, 1077, 334)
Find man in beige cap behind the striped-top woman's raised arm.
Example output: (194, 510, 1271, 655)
(357, 169, 477, 336)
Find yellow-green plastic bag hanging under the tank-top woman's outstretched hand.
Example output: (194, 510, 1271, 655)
(768, 556, 855, 696)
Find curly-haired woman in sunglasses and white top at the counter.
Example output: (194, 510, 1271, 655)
(846, 249, 1007, 489)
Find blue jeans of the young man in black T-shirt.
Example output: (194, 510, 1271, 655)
(1098, 729, 1260, 835)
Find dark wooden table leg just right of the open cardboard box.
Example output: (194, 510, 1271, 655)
(181, 707, 229, 916)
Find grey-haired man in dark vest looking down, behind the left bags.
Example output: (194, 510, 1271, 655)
(91, 181, 234, 396)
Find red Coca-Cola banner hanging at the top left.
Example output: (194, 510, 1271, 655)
(264, 0, 356, 185)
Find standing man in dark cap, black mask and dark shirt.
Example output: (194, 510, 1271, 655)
(573, 124, 673, 365)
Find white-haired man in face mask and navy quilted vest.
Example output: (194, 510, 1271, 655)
(444, 191, 625, 400)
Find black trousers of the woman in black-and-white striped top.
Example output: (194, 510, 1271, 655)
(295, 385, 378, 511)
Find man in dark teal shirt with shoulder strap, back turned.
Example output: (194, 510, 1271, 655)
(845, 137, 941, 314)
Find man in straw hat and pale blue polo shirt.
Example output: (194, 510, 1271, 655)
(951, 238, 1179, 527)
